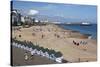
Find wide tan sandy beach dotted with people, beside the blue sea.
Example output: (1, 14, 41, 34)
(12, 24, 97, 62)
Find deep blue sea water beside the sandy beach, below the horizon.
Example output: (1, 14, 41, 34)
(59, 24, 97, 39)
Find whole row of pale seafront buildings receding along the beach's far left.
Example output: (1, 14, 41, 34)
(11, 9, 48, 26)
